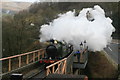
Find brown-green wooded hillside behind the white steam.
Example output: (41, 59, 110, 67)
(2, 2, 120, 57)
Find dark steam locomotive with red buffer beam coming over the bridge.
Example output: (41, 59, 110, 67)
(40, 39, 73, 65)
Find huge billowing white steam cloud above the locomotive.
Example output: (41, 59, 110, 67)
(40, 5, 115, 51)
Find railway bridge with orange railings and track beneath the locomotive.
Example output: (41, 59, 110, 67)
(0, 49, 88, 80)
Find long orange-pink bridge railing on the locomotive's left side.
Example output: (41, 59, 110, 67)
(0, 49, 45, 73)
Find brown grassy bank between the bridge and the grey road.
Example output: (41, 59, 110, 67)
(87, 52, 118, 78)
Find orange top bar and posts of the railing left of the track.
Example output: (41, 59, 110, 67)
(0, 49, 45, 73)
